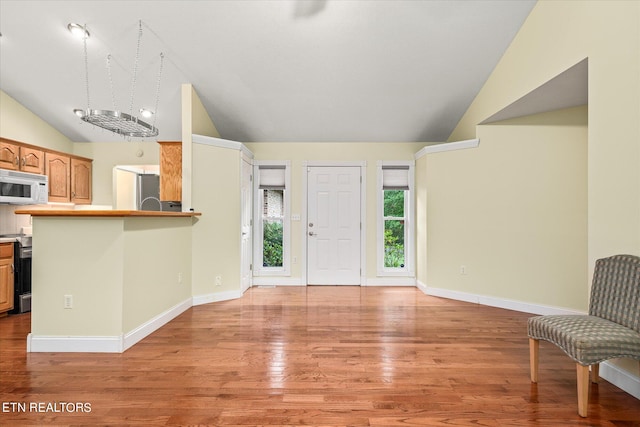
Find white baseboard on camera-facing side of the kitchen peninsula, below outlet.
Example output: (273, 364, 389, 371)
(27, 333, 124, 353)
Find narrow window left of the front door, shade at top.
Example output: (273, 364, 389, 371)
(254, 162, 289, 276)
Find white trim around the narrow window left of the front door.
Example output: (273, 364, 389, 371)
(253, 160, 291, 276)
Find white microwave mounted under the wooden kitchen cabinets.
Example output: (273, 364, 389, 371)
(0, 169, 49, 205)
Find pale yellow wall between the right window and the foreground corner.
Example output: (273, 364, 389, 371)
(419, 107, 588, 311)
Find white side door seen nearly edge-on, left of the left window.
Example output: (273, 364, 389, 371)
(240, 157, 253, 292)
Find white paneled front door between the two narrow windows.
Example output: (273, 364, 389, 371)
(306, 166, 361, 285)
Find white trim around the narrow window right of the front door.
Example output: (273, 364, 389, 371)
(376, 160, 415, 277)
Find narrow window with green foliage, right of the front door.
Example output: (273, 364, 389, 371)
(378, 162, 414, 276)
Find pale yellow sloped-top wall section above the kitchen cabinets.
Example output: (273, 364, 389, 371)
(0, 91, 73, 153)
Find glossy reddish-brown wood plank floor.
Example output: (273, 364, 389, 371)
(0, 286, 640, 427)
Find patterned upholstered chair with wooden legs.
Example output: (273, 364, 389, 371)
(528, 255, 640, 417)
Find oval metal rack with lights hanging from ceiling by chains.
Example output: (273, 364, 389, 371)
(68, 21, 164, 138)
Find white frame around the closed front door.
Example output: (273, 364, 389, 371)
(300, 160, 367, 286)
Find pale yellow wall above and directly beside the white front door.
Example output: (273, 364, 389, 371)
(245, 142, 425, 278)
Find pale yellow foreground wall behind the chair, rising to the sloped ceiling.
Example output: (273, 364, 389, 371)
(451, 1, 640, 270)
